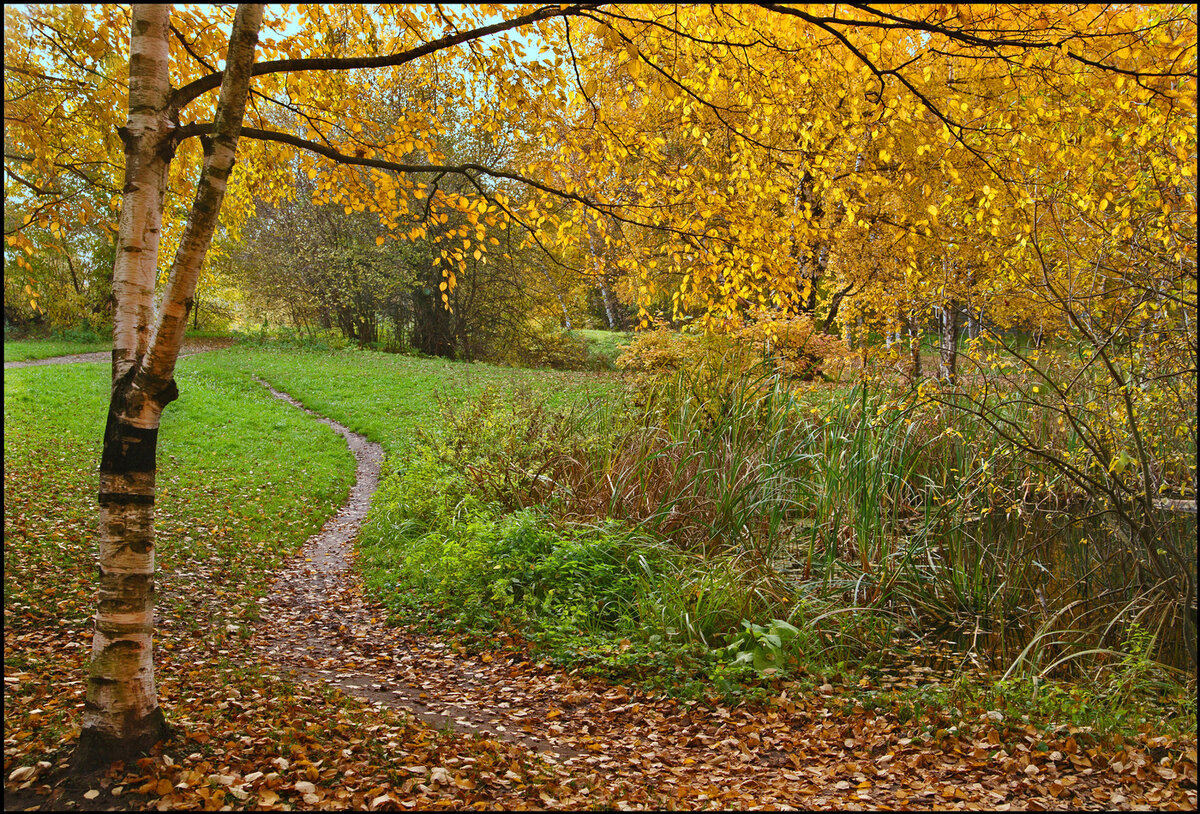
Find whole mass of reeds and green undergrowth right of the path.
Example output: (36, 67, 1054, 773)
(360, 350, 1194, 720)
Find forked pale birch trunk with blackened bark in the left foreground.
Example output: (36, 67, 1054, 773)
(72, 5, 263, 771)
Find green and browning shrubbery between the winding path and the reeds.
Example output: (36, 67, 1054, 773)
(360, 379, 883, 694)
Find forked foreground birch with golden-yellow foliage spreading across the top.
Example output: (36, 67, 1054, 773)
(5, 4, 1195, 764)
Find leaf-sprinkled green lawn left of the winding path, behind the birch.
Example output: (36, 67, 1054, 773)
(4, 359, 354, 638)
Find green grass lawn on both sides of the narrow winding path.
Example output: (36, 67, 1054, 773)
(4, 347, 613, 643)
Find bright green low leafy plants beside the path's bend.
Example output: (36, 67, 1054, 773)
(361, 454, 670, 644)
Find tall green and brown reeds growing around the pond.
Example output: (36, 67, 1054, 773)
(427, 357, 1195, 671)
